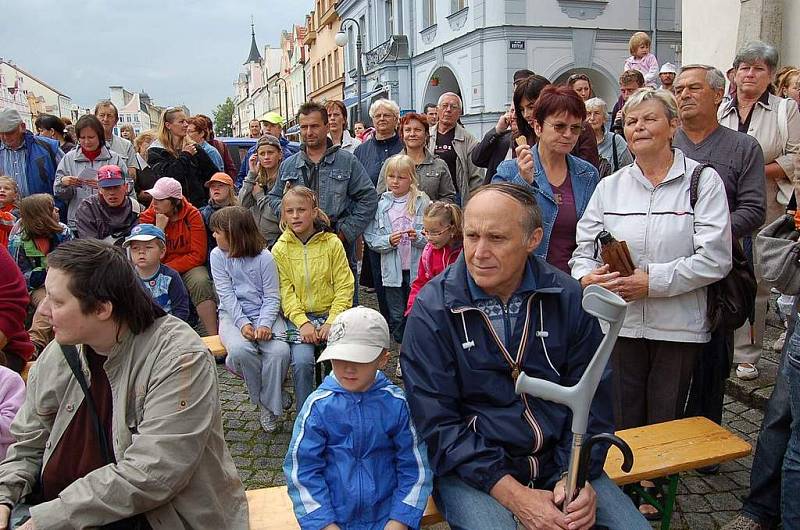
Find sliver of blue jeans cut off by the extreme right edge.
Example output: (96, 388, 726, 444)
(780, 326, 800, 528)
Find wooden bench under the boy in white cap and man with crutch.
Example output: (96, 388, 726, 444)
(247, 418, 751, 530)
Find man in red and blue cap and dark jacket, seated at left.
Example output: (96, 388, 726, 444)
(75, 164, 144, 244)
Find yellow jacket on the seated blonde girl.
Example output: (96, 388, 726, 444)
(272, 229, 355, 329)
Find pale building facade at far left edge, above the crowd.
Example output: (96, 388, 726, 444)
(0, 58, 72, 128)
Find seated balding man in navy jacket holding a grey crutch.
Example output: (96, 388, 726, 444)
(401, 183, 650, 530)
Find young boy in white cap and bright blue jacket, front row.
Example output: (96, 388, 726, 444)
(283, 307, 432, 530)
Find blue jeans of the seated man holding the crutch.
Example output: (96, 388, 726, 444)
(433, 473, 651, 530)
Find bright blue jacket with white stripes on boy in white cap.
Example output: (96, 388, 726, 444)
(283, 371, 432, 530)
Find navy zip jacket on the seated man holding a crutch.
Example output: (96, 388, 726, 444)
(401, 254, 614, 493)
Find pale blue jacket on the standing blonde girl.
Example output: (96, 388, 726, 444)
(364, 191, 431, 287)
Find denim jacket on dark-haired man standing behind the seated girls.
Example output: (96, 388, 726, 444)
(269, 145, 378, 242)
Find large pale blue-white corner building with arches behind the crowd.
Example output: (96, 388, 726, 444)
(336, 0, 682, 135)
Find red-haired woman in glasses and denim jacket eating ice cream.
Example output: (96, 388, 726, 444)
(492, 83, 599, 274)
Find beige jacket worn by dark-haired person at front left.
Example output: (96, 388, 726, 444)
(0, 316, 249, 530)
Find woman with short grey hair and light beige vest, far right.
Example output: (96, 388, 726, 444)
(718, 41, 800, 379)
